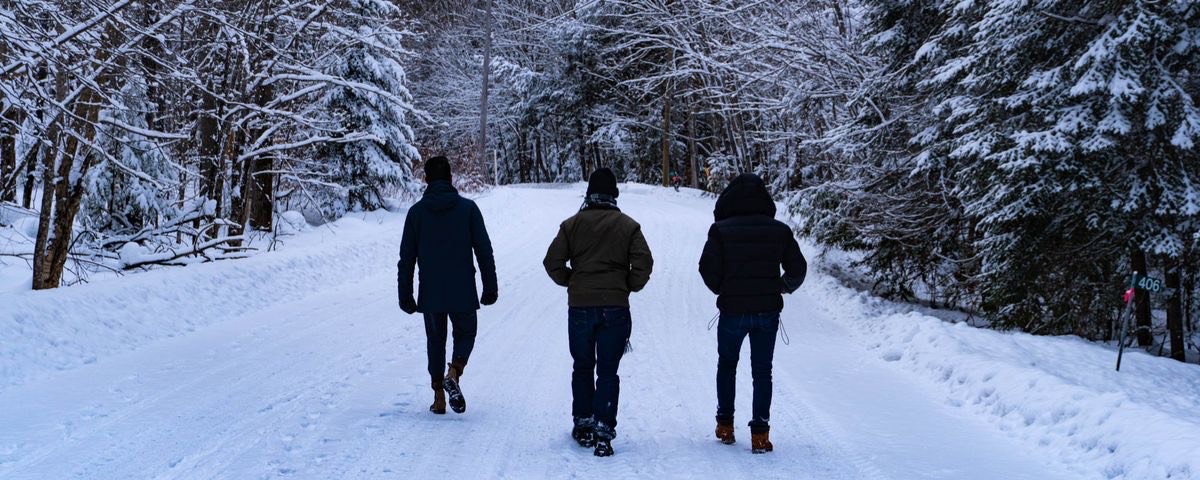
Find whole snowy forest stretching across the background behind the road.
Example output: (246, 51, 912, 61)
(0, 0, 1200, 360)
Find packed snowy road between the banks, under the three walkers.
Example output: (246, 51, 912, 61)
(0, 185, 1087, 479)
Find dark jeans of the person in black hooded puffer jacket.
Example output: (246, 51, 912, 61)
(716, 313, 779, 433)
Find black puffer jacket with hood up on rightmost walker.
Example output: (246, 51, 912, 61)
(700, 174, 808, 314)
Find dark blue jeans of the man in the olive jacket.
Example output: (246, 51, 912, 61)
(568, 307, 632, 428)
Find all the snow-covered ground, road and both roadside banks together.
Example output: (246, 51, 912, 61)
(0, 185, 1200, 479)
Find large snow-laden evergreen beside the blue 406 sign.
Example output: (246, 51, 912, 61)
(940, 1, 1200, 337)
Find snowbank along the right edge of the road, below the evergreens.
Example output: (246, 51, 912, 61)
(805, 262, 1200, 479)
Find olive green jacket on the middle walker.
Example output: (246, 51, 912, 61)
(542, 209, 654, 307)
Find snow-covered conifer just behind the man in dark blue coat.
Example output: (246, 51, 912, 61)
(318, 0, 420, 214)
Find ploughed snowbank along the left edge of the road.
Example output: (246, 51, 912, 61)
(0, 212, 403, 391)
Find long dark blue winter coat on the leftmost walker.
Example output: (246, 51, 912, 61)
(396, 181, 497, 313)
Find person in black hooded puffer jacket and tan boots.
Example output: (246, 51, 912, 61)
(700, 174, 808, 454)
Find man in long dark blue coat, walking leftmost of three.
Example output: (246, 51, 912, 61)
(396, 156, 498, 414)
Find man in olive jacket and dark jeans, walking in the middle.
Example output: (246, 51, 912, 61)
(542, 168, 654, 456)
